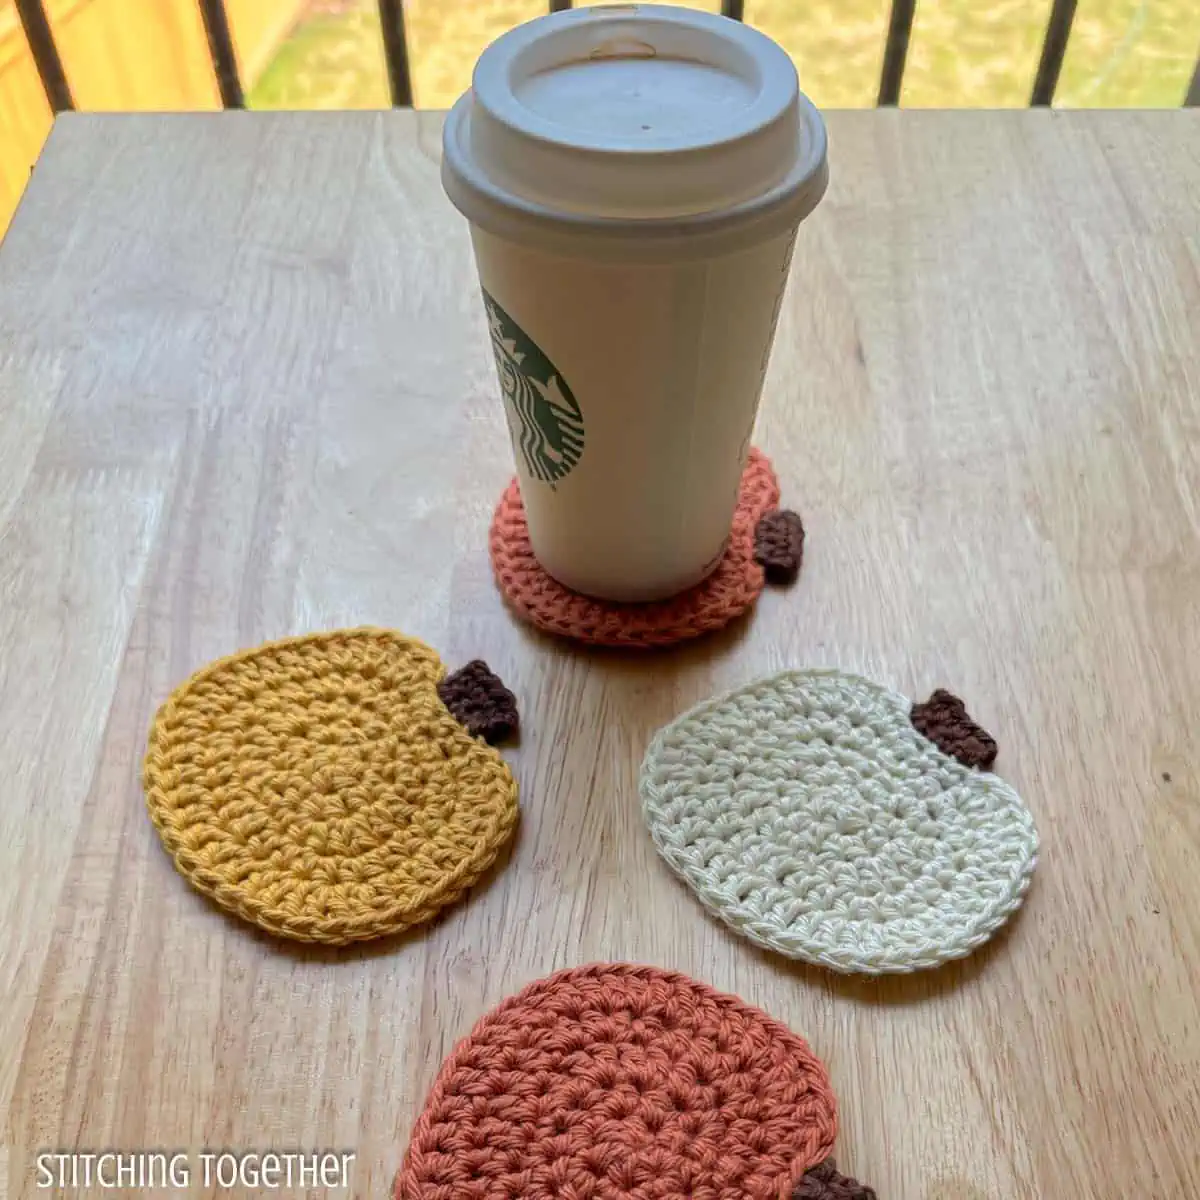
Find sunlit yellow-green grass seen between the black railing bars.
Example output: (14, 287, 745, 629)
(248, 0, 1200, 108)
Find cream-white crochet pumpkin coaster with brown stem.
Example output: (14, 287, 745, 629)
(641, 671, 1038, 974)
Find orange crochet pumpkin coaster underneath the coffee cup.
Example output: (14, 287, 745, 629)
(488, 449, 804, 649)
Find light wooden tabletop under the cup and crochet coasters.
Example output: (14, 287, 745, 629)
(0, 112, 1200, 1200)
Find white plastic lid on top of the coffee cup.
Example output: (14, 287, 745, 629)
(443, 5, 828, 255)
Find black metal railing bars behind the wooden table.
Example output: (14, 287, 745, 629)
(16, 0, 1200, 113)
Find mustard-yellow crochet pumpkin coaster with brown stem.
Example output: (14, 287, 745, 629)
(143, 629, 517, 944)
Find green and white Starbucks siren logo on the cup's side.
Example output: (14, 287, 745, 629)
(484, 292, 583, 486)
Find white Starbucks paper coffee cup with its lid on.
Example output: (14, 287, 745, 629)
(442, 5, 828, 601)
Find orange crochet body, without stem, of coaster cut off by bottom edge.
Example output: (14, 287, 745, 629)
(395, 964, 836, 1200)
